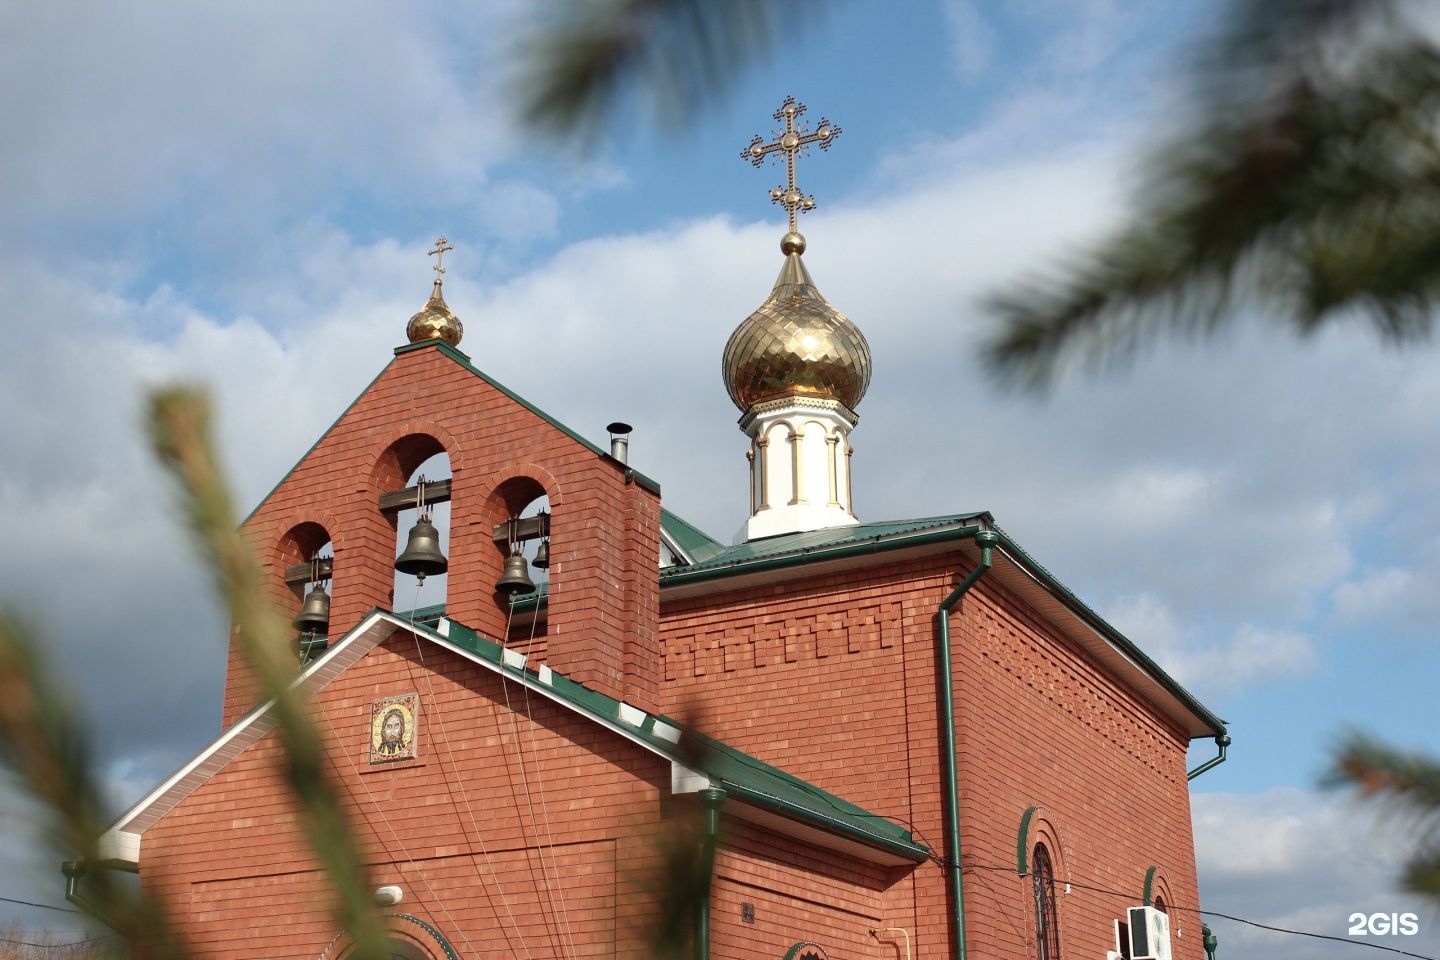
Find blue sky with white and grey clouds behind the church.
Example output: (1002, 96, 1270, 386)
(0, 0, 1440, 957)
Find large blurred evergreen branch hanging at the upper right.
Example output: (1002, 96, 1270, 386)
(982, 0, 1440, 389)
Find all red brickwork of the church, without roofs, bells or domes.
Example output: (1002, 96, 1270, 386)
(132, 336, 1202, 960)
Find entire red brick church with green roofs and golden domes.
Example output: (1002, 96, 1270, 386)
(98, 99, 1230, 960)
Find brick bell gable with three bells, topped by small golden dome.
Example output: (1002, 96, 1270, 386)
(236, 237, 660, 723)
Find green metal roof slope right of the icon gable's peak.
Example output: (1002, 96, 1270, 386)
(432, 620, 930, 862)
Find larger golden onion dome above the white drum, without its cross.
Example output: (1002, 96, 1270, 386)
(721, 233, 870, 412)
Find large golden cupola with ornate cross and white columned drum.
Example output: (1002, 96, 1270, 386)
(721, 96, 870, 543)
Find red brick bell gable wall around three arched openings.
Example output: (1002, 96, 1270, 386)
(225, 347, 660, 725)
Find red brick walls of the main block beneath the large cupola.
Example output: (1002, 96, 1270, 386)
(661, 554, 1202, 960)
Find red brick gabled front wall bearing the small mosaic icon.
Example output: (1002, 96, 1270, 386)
(150, 635, 670, 960)
